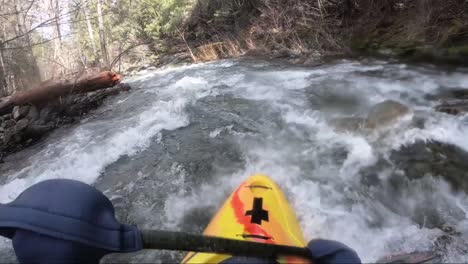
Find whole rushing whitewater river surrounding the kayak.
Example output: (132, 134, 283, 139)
(0, 57, 468, 262)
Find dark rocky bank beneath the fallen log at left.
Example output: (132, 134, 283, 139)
(0, 83, 130, 162)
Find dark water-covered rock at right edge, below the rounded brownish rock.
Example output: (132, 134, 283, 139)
(390, 141, 468, 192)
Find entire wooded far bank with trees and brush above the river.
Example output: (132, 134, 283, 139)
(0, 0, 468, 96)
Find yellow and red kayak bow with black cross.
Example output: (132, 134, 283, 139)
(182, 174, 309, 263)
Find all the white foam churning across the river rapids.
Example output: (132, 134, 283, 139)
(0, 58, 468, 262)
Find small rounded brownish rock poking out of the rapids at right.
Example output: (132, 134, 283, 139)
(367, 100, 410, 128)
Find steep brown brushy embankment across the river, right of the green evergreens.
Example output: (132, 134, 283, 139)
(178, 0, 468, 65)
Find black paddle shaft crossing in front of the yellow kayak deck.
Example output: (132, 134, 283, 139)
(141, 230, 312, 259)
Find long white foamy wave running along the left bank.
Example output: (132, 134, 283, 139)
(0, 66, 216, 203)
